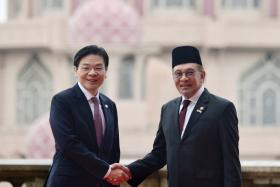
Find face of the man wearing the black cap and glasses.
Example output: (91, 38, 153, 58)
(173, 63, 205, 98)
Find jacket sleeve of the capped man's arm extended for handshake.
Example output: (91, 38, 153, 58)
(127, 106, 166, 187)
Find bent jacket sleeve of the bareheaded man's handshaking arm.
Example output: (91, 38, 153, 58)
(50, 95, 109, 179)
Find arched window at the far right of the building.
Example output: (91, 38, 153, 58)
(240, 55, 280, 126)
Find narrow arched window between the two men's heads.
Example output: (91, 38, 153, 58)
(118, 55, 135, 99)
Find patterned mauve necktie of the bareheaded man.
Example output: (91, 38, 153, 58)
(91, 97, 103, 147)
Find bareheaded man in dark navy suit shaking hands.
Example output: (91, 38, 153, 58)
(45, 45, 128, 187)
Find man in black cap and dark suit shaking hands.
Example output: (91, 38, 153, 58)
(115, 46, 241, 187)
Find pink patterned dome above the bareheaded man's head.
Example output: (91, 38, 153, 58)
(69, 0, 141, 43)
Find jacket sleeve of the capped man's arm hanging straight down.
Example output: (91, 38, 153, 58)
(220, 103, 241, 187)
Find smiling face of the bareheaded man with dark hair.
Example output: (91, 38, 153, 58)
(75, 54, 106, 95)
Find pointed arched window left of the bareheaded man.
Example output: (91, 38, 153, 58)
(17, 55, 52, 124)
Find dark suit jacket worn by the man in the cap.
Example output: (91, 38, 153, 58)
(128, 89, 241, 187)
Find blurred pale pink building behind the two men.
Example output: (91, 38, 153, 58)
(0, 0, 280, 160)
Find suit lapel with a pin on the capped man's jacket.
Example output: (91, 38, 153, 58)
(182, 89, 209, 140)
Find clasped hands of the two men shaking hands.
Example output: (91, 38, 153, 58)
(104, 163, 132, 185)
